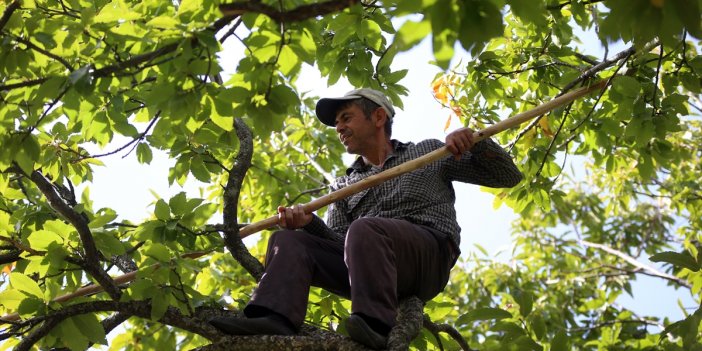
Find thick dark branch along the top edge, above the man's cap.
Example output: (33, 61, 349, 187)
(219, 0, 360, 22)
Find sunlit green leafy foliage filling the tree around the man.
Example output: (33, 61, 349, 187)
(0, 0, 702, 350)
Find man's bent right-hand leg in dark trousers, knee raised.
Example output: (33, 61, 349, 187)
(345, 218, 453, 327)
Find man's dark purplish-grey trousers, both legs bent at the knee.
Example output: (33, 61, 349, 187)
(244, 218, 457, 328)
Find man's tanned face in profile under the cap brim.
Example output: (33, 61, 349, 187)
(334, 104, 375, 155)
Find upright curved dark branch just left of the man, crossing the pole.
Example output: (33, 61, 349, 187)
(222, 118, 263, 280)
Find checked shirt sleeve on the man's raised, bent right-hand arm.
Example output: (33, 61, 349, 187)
(441, 139, 523, 188)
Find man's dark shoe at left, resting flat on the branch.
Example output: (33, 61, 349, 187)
(208, 315, 295, 335)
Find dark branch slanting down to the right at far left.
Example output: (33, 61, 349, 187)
(30, 171, 122, 300)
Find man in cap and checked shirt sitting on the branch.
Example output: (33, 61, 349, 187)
(210, 89, 522, 349)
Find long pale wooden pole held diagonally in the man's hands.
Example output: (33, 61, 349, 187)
(0, 80, 607, 323)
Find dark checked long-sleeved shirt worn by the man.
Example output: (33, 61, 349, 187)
(304, 139, 522, 249)
